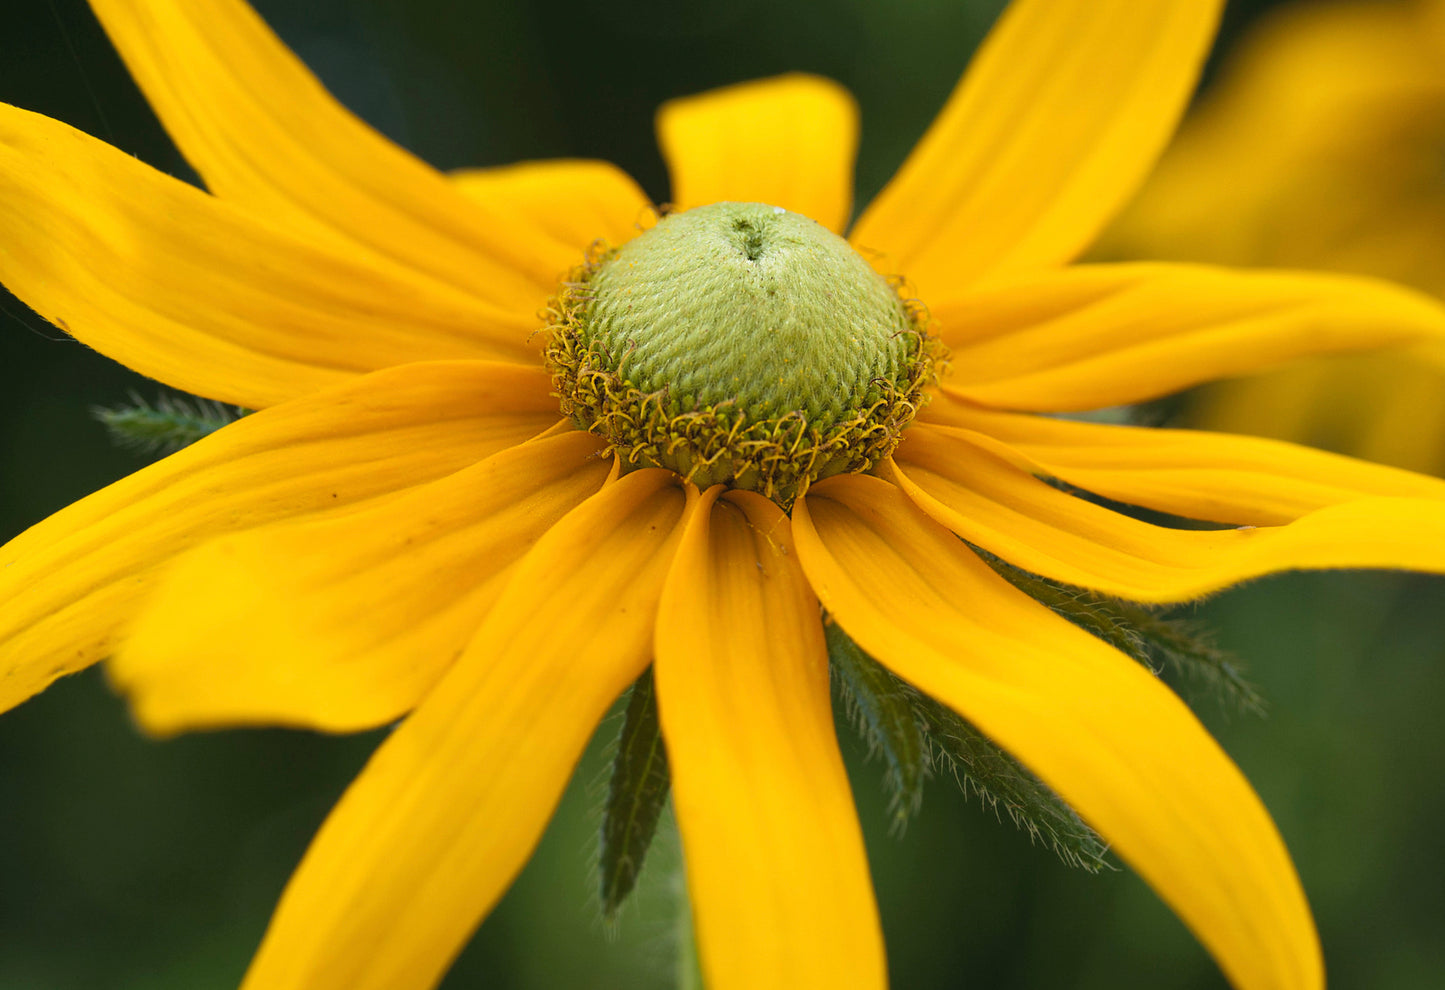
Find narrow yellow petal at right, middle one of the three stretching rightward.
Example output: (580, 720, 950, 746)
(922, 396, 1445, 526)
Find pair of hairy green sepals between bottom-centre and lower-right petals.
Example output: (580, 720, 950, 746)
(827, 621, 1105, 871)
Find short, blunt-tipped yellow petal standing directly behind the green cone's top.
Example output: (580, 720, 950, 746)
(657, 74, 858, 234)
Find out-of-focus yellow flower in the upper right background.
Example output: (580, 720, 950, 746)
(1105, 0, 1445, 474)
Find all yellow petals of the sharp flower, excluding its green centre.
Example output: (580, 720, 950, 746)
(8, 0, 1445, 990)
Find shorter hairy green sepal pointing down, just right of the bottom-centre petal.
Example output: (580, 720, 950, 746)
(824, 619, 929, 831)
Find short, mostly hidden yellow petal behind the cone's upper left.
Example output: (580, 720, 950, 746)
(451, 159, 656, 258)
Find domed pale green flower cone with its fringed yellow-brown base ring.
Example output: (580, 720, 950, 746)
(548, 202, 939, 506)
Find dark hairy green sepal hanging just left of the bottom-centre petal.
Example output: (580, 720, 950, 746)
(598, 668, 672, 921)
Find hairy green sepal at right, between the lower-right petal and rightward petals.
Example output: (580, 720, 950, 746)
(974, 548, 1264, 714)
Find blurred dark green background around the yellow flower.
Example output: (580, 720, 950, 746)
(0, 0, 1445, 990)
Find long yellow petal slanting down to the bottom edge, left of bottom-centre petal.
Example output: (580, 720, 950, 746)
(236, 470, 683, 990)
